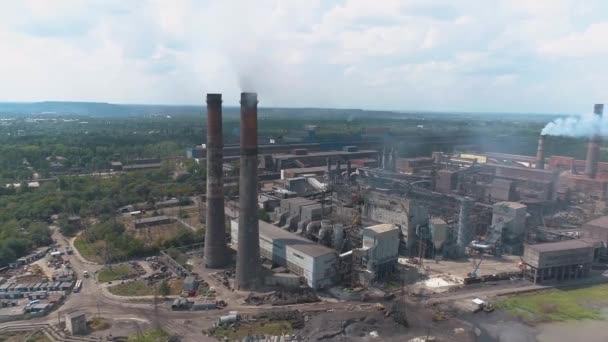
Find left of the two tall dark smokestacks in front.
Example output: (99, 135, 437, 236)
(205, 94, 228, 268)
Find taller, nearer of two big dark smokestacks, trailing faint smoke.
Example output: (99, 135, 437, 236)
(236, 93, 260, 290)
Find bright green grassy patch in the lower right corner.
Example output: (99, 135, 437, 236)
(497, 285, 608, 322)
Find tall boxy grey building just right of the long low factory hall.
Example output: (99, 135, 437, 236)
(353, 224, 399, 284)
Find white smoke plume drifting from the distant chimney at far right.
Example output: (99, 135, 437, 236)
(541, 114, 608, 138)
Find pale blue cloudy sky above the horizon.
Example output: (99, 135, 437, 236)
(0, 0, 608, 113)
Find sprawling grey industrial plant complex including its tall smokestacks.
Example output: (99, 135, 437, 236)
(202, 93, 608, 291)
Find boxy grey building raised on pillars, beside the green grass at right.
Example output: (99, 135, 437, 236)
(523, 240, 594, 284)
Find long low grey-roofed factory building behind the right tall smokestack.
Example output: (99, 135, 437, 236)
(230, 220, 337, 289)
